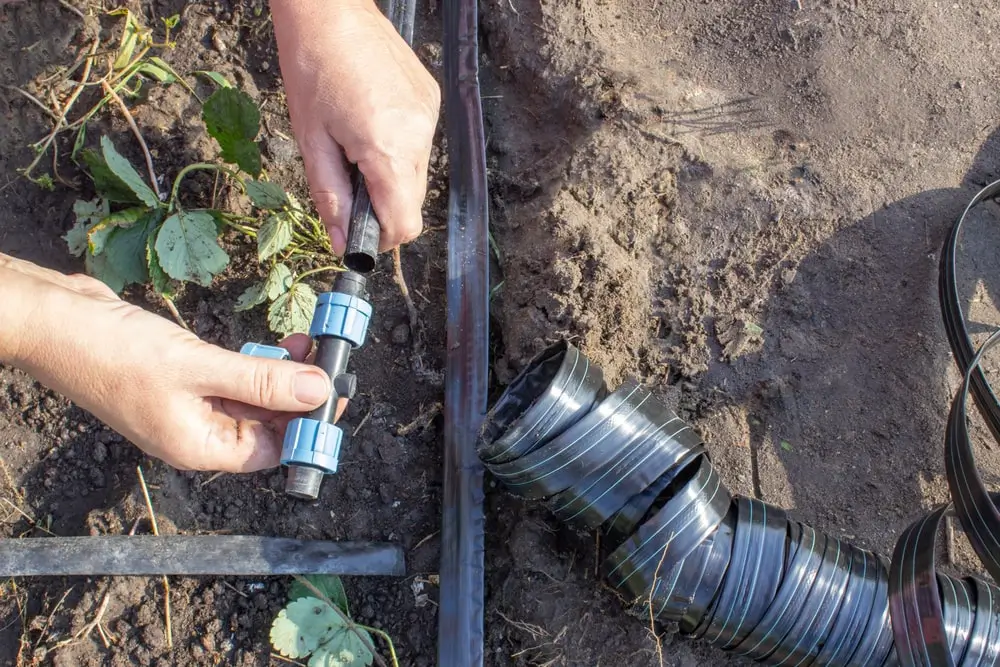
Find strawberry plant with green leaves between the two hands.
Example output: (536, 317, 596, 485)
(65, 81, 342, 335)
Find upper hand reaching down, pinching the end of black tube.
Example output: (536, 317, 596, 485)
(271, 0, 441, 254)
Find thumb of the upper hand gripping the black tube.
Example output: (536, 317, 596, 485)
(300, 127, 353, 255)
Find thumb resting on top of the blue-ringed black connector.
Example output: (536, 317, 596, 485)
(196, 344, 333, 412)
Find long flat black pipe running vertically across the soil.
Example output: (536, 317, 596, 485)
(437, 0, 489, 667)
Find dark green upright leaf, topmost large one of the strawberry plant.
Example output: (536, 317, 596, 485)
(201, 88, 261, 176)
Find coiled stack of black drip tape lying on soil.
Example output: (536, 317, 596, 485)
(478, 342, 1000, 667)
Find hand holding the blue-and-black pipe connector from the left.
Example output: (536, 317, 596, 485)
(0, 255, 331, 472)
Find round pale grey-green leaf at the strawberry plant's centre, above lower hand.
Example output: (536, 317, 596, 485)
(155, 211, 229, 287)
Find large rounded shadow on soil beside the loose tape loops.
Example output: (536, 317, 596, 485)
(707, 122, 1000, 554)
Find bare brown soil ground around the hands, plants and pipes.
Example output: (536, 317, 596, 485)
(0, 0, 1000, 667)
